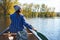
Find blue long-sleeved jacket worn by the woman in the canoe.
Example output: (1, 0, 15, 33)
(9, 13, 32, 33)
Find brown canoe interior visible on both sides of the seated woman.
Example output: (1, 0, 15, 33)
(0, 29, 39, 40)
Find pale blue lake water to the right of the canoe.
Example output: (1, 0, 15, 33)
(27, 17, 60, 40)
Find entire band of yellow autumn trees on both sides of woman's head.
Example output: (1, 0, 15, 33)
(0, 0, 56, 18)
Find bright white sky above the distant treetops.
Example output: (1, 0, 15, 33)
(18, 0, 60, 12)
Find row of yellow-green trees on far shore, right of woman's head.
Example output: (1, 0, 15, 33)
(20, 3, 56, 18)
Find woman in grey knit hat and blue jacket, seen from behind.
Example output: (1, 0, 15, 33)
(9, 5, 35, 40)
